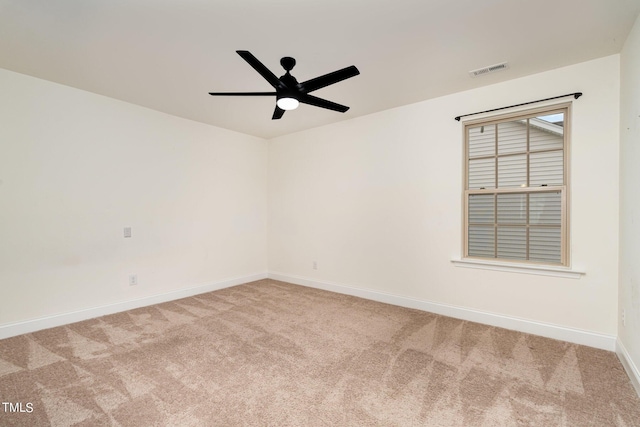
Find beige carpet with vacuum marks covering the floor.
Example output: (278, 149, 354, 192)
(0, 280, 640, 427)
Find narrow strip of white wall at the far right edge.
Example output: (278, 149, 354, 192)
(618, 18, 640, 393)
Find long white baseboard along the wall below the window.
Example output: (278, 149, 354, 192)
(269, 272, 616, 351)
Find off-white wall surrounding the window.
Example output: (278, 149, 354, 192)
(268, 55, 620, 347)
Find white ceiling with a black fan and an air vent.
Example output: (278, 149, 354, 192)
(0, 0, 640, 138)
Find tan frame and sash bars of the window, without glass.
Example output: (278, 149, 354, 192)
(462, 102, 572, 268)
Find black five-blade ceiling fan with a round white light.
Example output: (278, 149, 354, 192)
(209, 50, 360, 120)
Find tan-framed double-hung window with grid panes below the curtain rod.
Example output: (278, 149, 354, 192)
(463, 104, 569, 266)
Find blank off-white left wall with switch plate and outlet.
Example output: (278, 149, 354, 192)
(0, 69, 267, 332)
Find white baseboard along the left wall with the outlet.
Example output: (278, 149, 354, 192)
(0, 273, 267, 339)
